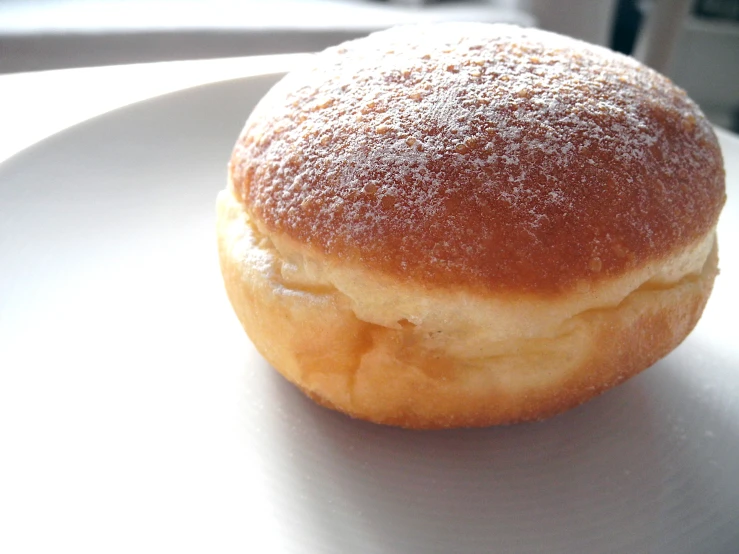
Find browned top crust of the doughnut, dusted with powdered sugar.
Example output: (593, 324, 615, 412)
(230, 23, 725, 294)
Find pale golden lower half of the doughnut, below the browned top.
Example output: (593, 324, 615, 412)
(218, 191, 717, 429)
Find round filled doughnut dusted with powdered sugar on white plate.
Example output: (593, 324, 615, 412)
(218, 24, 725, 428)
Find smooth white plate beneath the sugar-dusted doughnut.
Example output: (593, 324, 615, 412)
(0, 77, 739, 554)
